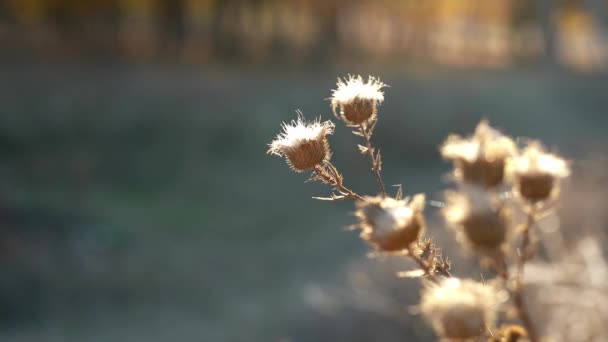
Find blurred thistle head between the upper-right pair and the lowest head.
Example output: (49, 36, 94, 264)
(443, 186, 510, 254)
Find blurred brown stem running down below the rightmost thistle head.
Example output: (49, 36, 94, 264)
(513, 205, 538, 342)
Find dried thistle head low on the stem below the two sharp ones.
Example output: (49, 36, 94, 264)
(355, 194, 425, 252)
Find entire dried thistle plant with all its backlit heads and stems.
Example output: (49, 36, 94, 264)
(268, 76, 570, 342)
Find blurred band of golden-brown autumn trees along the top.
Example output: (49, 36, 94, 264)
(0, 0, 608, 70)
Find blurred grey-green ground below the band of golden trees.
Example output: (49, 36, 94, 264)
(0, 66, 608, 342)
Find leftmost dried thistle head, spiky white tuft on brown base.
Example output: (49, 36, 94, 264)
(268, 112, 334, 172)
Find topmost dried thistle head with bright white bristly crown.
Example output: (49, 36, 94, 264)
(331, 76, 386, 125)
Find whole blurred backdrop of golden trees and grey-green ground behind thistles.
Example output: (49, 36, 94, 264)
(0, 0, 608, 342)
